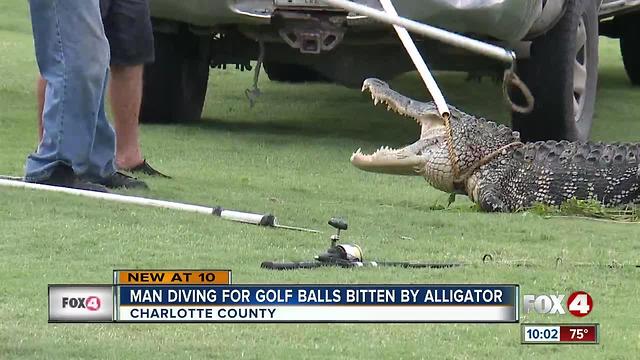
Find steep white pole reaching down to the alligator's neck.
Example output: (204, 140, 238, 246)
(380, 0, 449, 118)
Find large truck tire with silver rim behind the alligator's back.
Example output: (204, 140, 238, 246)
(512, 0, 599, 141)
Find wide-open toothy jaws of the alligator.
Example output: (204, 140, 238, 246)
(351, 79, 438, 175)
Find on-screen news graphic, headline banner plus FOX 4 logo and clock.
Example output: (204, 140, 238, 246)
(48, 270, 599, 344)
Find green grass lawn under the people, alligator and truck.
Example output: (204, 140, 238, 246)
(0, 1, 640, 359)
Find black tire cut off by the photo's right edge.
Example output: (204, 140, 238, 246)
(620, 14, 640, 86)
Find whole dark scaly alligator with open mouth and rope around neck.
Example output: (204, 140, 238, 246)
(351, 79, 640, 212)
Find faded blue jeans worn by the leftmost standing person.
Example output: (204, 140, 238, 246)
(25, 0, 115, 182)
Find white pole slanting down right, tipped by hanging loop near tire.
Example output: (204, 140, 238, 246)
(323, 0, 516, 64)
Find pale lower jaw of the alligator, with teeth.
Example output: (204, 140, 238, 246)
(351, 147, 424, 175)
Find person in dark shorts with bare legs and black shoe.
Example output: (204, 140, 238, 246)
(37, 0, 169, 178)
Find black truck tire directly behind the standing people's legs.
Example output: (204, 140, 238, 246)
(140, 29, 210, 124)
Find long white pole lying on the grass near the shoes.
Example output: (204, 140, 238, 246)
(0, 176, 319, 233)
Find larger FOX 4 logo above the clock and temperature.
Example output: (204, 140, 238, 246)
(523, 291, 593, 317)
